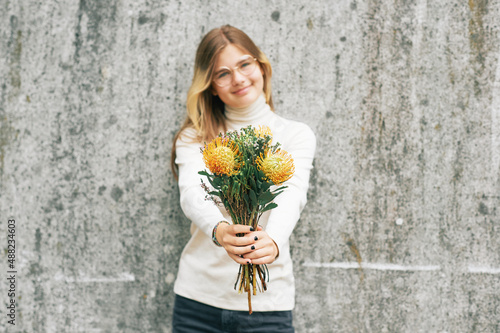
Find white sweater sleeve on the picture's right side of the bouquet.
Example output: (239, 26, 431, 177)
(266, 124, 316, 249)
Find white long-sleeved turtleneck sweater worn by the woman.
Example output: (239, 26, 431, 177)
(174, 95, 316, 311)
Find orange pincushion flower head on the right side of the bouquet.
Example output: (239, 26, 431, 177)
(257, 149, 295, 185)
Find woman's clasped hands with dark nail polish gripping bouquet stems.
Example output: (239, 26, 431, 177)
(216, 223, 279, 265)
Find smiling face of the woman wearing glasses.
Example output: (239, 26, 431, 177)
(212, 44, 264, 108)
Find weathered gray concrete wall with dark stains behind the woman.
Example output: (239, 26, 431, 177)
(0, 0, 500, 333)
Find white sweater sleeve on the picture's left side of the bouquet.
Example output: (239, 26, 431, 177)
(175, 129, 226, 237)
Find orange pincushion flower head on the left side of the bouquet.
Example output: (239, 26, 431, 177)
(203, 137, 240, 176)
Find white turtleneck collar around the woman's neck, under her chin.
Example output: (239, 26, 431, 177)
(225, 94, 272, 126)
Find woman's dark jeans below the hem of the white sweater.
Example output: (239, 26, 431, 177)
(172, 295, 295, 333)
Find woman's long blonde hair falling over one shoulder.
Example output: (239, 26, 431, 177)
(170, 25, 274, 179)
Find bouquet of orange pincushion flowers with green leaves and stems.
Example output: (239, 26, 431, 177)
(199, 126, 295, 314)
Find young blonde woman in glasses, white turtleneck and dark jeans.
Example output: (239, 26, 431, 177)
(172, 25, 316, 333)
